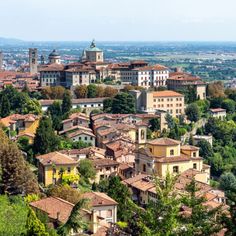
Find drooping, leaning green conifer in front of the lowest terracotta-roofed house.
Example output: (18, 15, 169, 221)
(58, 199, 88, 236)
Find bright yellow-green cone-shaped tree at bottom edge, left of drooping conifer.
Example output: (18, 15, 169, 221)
(25, 208, 49, 236)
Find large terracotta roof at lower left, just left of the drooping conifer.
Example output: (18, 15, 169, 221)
(30, 197, 74, 223)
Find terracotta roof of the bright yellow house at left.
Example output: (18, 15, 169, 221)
(36, 152, 78, 166)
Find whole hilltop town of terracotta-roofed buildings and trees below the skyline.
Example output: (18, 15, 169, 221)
(0, 40, 236, 236)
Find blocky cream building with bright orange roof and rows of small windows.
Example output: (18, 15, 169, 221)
(131, 90, 185, 117)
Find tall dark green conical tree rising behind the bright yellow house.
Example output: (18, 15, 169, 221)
(33, 116, 59, 154)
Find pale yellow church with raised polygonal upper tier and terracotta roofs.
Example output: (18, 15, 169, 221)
(135, 138, 210, 183)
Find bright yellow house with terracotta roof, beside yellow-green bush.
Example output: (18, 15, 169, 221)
(37, 152, 78, 186)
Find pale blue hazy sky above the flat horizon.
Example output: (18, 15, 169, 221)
(0, 0, 236, 41)
